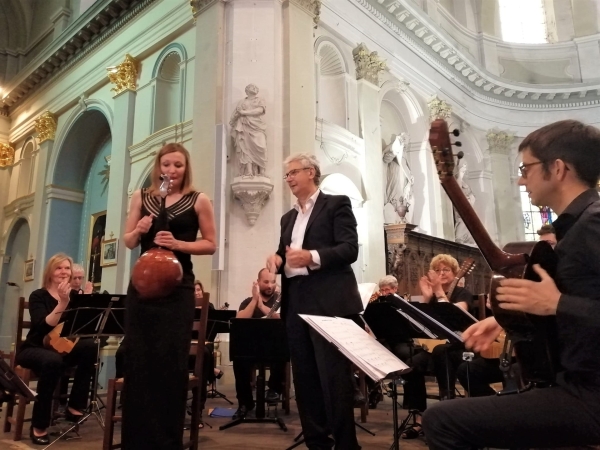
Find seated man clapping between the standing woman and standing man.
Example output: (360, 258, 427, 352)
(233, 269, 285, 420)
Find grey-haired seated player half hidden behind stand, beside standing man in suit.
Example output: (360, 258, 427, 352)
(378, 275, 431, 439)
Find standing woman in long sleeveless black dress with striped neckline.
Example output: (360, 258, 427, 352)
(122, 144, 216, 450)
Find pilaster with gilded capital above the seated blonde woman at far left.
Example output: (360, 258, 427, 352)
(29, 111, 56, 286)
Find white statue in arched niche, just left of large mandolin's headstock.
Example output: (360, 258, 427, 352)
(383, 133, 414, 223)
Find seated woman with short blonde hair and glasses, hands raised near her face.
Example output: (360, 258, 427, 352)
(419, 254, 473, 400)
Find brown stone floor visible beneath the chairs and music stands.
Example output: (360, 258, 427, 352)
(0, 374, 433, 450)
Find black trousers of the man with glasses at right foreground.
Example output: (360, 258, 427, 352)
(423, 386, 600, 450)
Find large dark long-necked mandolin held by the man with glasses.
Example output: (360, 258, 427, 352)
(429, 119, 559, 385)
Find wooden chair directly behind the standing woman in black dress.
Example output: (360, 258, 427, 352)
(102, 292, 210, 450)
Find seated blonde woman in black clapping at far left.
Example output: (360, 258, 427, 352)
(16, 253, 97, 445)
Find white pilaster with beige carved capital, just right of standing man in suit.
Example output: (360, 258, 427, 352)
(352, 44, 386, 281)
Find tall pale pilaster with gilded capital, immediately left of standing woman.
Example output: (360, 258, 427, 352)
(102, 55, 138, 294)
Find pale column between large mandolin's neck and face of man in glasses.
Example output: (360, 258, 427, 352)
(486, 129, 523, 245)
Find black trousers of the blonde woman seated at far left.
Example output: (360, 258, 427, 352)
(16, 339, 98, 430)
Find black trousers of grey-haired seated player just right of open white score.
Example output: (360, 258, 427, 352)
(391, 342, 431, 412)
